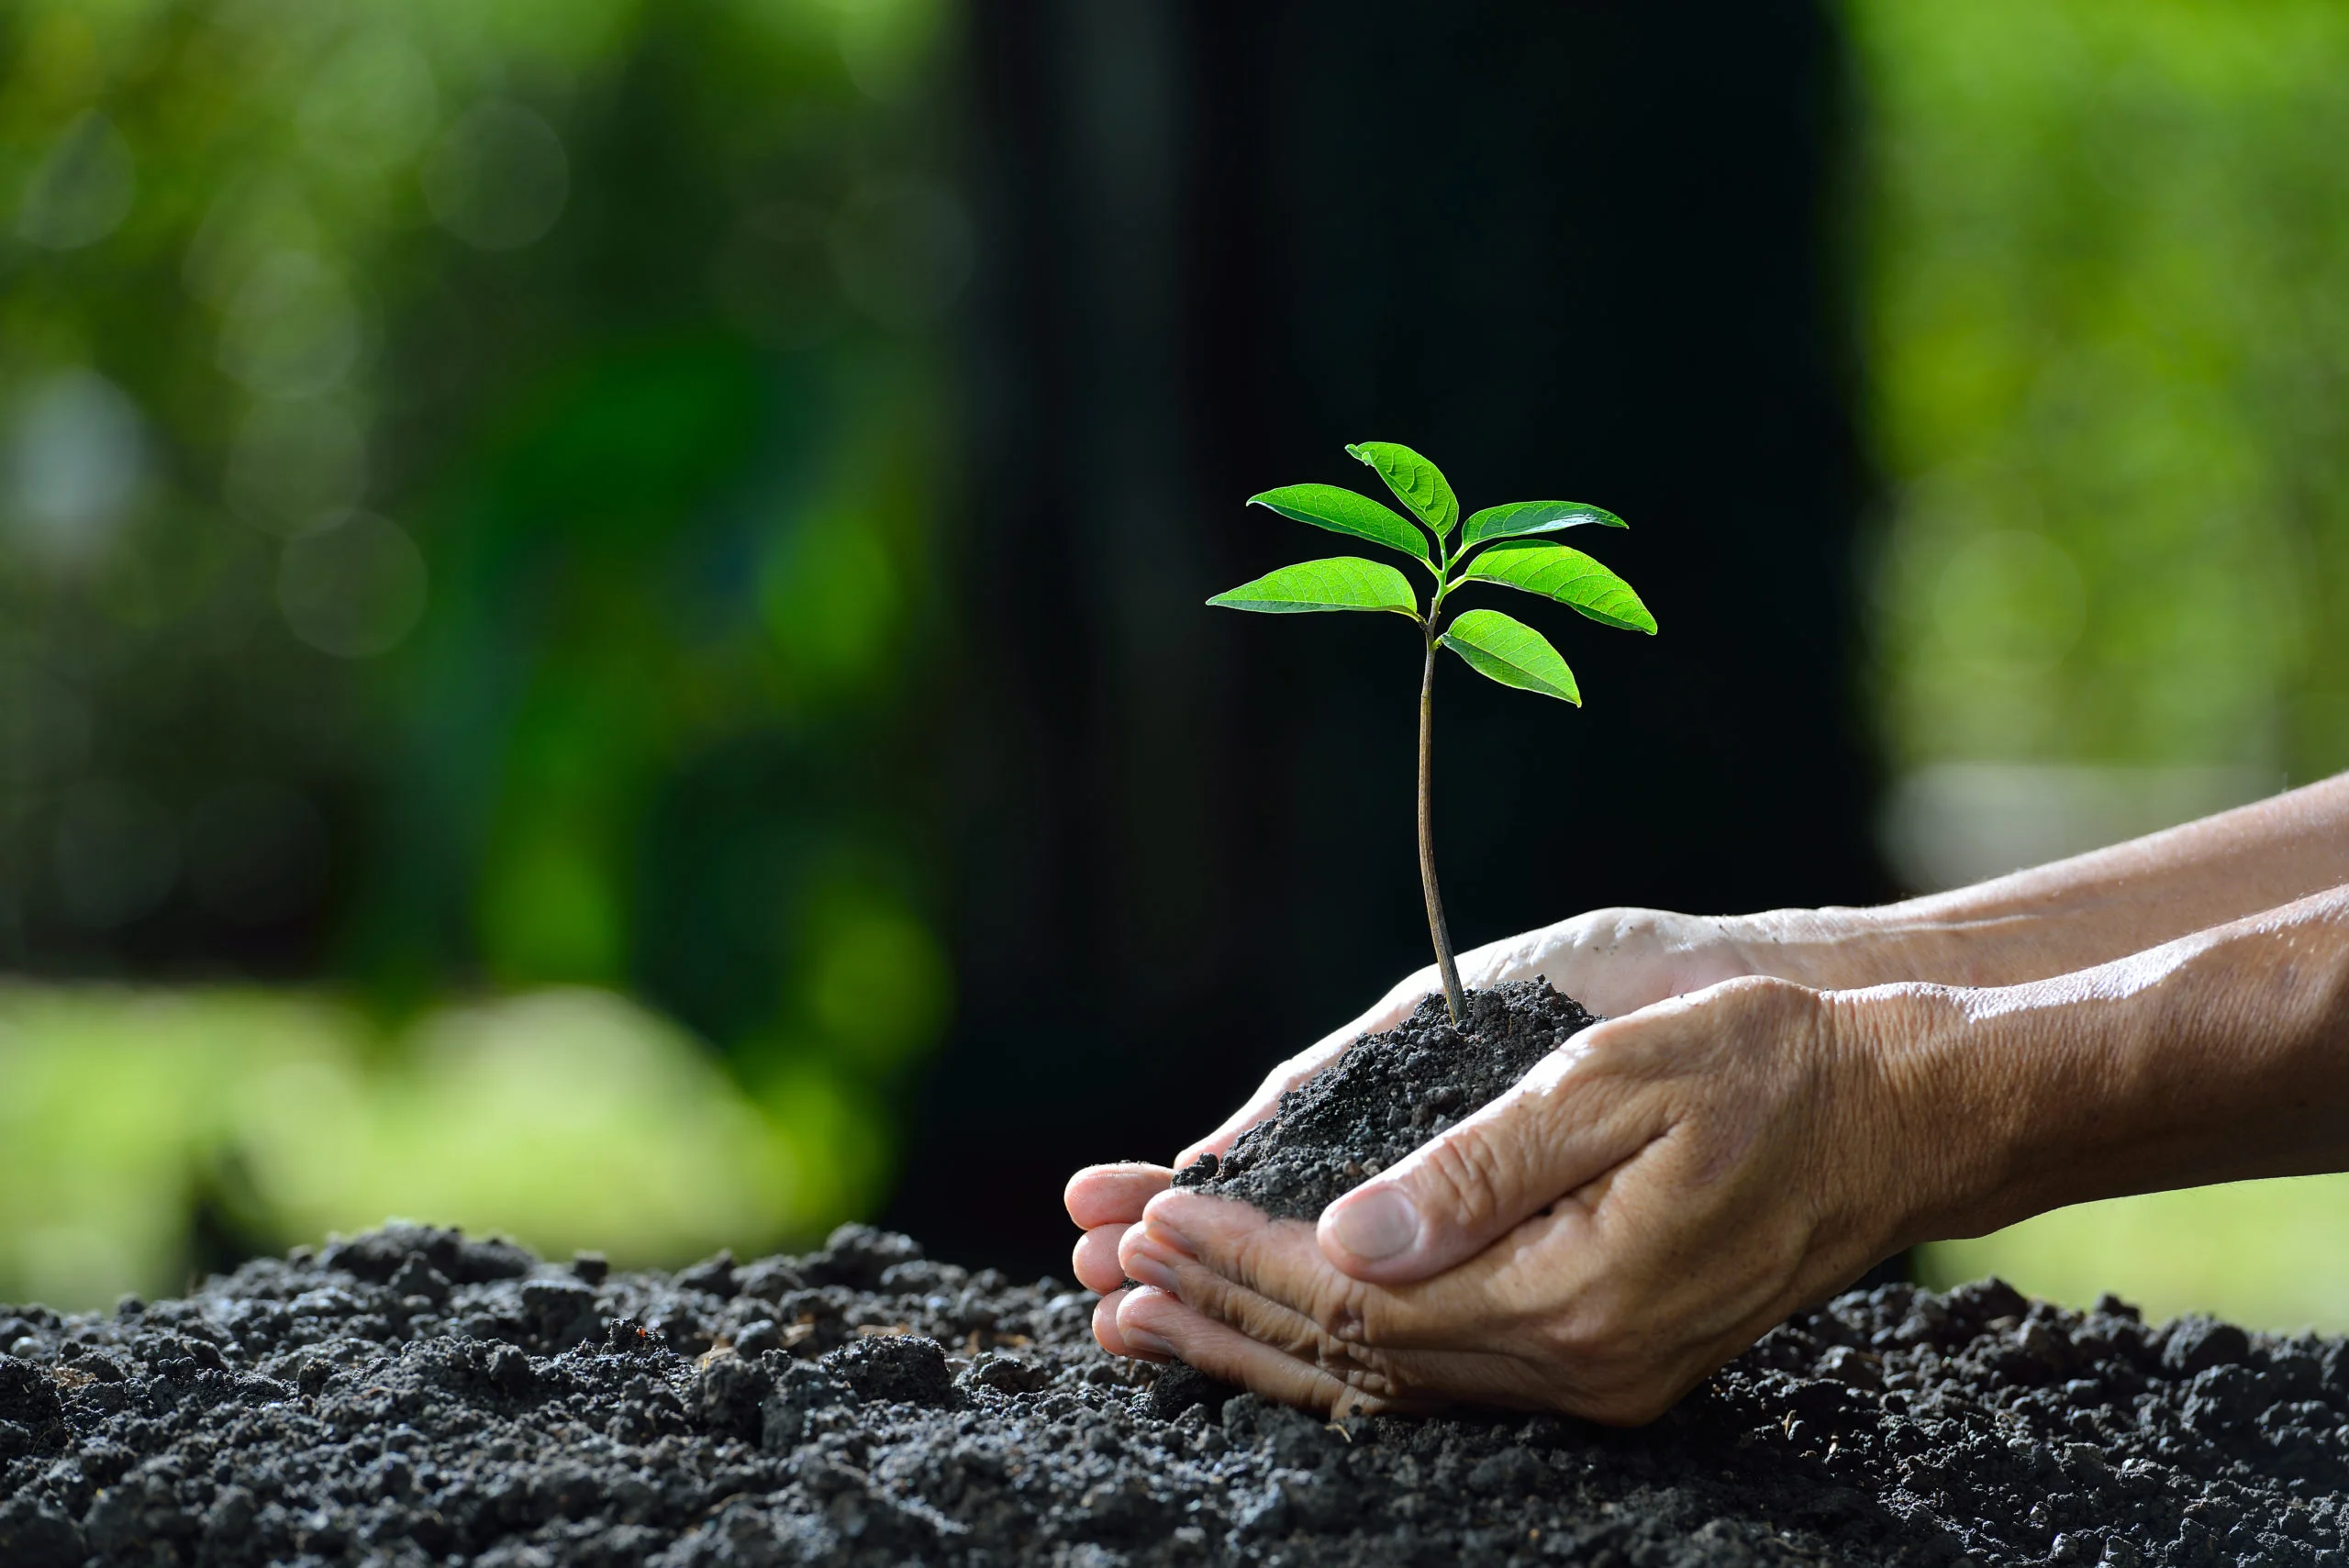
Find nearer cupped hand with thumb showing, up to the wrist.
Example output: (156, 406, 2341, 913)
(1099, 979, 1945, 1422)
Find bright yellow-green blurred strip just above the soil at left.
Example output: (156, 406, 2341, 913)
(0, 986, 884, 1303)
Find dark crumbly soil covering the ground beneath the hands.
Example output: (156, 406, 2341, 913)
(0, 1225, 2349, 1568)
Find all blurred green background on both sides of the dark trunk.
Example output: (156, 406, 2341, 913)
(0, 0, 2349, 1326)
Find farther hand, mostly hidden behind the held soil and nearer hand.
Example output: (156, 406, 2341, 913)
(1064, 908, 1754, 1354)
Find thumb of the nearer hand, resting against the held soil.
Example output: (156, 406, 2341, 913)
(1318, 1026, 1665, 1284)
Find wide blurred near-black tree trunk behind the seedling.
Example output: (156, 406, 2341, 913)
(888, 0, 1887, 1268)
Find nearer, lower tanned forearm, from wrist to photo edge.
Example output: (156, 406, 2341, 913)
(1869, 887, 2349, 1240)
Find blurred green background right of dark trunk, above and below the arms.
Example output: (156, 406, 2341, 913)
(1846, 0, 2349, 1329)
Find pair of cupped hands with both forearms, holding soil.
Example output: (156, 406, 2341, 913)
(1069, 779, 2349, 1422)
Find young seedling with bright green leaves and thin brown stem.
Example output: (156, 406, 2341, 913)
(1208, 441, 1656, 1029)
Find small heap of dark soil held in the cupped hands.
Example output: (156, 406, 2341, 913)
(1174, 976, 1598, 1220)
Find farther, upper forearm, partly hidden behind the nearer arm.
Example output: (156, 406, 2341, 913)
(1721, 774, 2349, 988)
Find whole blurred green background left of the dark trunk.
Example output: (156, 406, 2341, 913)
(0, 0, 973, 1305)
